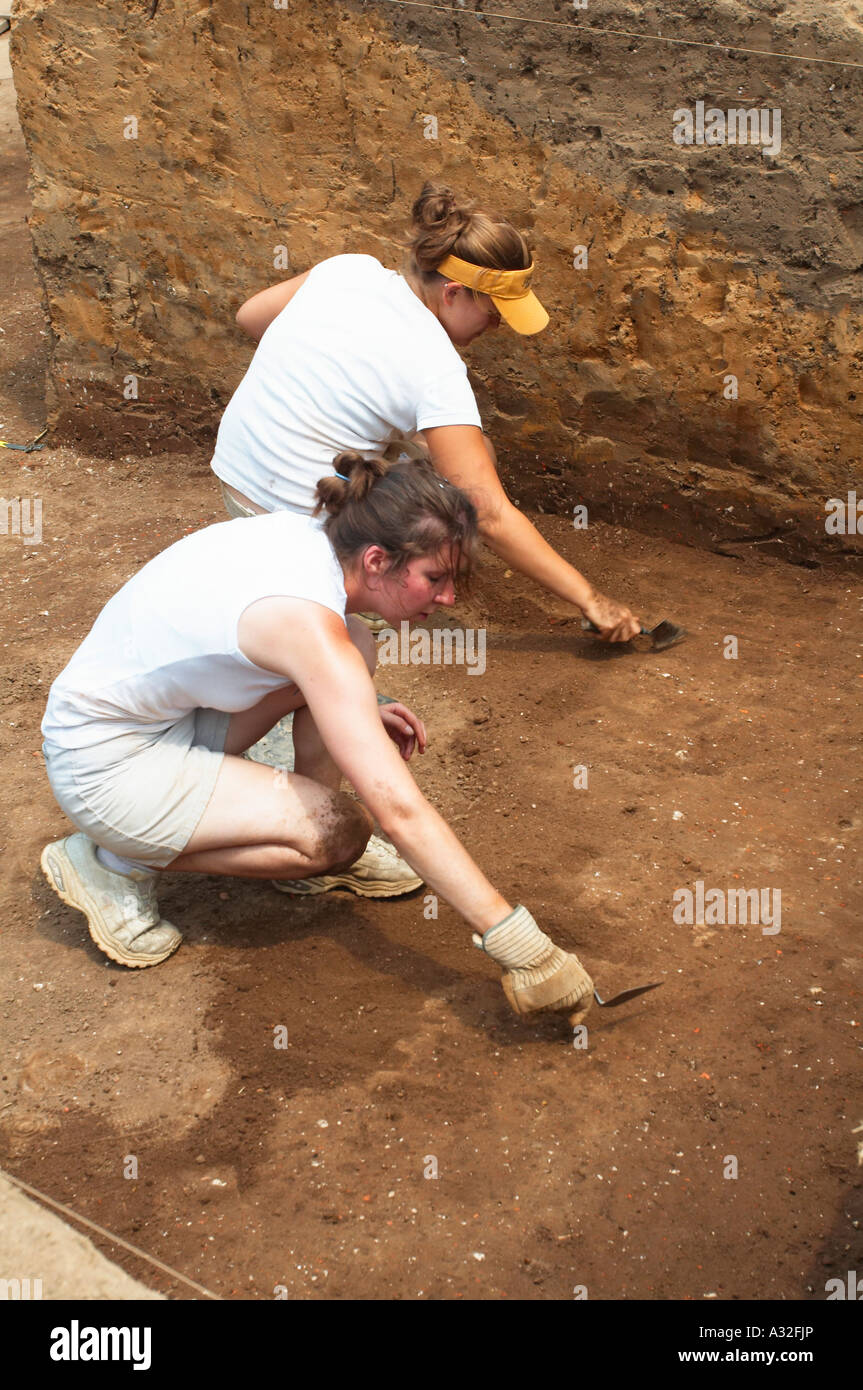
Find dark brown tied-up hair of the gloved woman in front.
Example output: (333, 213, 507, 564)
(313, 450, 478, 589)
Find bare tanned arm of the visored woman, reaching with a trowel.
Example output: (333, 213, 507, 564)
(422, 425, 641, 642)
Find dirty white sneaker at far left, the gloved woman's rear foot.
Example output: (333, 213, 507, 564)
(40, 831, 182, 967)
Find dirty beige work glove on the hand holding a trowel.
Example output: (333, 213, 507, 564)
(474, 906, 593, 1026)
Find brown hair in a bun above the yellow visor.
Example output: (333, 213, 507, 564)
(403, 183, 531, 304)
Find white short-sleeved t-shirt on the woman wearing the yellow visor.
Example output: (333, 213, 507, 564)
(211, 256, 482, 513)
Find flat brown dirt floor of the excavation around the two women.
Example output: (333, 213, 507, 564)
(0, 35, 863, 1300)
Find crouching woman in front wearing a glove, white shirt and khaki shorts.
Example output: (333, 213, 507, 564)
(42, 453, 592, 1019)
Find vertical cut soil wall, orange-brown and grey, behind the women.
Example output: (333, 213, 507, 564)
(13, 0, 863, 560)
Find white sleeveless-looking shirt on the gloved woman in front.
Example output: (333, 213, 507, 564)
(42, 512, 347, 748)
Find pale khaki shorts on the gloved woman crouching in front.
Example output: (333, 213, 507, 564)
(42, 709, 231, 869)
